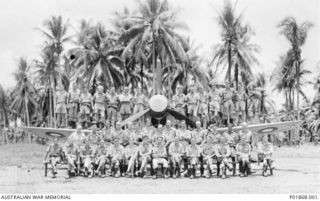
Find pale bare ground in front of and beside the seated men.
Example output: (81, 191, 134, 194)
(0, 144, 320, 194)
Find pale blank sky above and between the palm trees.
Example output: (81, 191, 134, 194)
(0, 0, 320, 110)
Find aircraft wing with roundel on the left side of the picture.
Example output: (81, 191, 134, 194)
(22, 127, 91, 140)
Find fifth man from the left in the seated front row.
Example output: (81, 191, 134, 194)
(110, 136, 125, 178)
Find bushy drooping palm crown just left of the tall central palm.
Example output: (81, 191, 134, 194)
(70, 24, 124, 88)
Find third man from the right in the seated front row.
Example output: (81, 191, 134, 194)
(215, 136, 232, 179)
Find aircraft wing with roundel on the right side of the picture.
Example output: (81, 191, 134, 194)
(217, 121, 302, 135)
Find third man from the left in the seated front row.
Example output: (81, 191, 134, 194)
(80, 140, 95, 177)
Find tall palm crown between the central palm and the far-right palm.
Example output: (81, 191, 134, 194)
(210, 1, 260, 90)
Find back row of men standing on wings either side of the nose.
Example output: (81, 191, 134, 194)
(55, 82, 245, 127)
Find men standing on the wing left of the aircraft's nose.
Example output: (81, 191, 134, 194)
(55, 85, 147, 128)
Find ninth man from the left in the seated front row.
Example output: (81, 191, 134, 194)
(169, 136, 184, 179)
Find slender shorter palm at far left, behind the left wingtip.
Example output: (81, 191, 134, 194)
(10, 58, 38, 141)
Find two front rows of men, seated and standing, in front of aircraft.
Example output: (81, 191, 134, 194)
(44, 121, 273, 178)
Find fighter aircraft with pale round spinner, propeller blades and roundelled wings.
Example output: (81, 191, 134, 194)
(22, 95, 301, 140)
